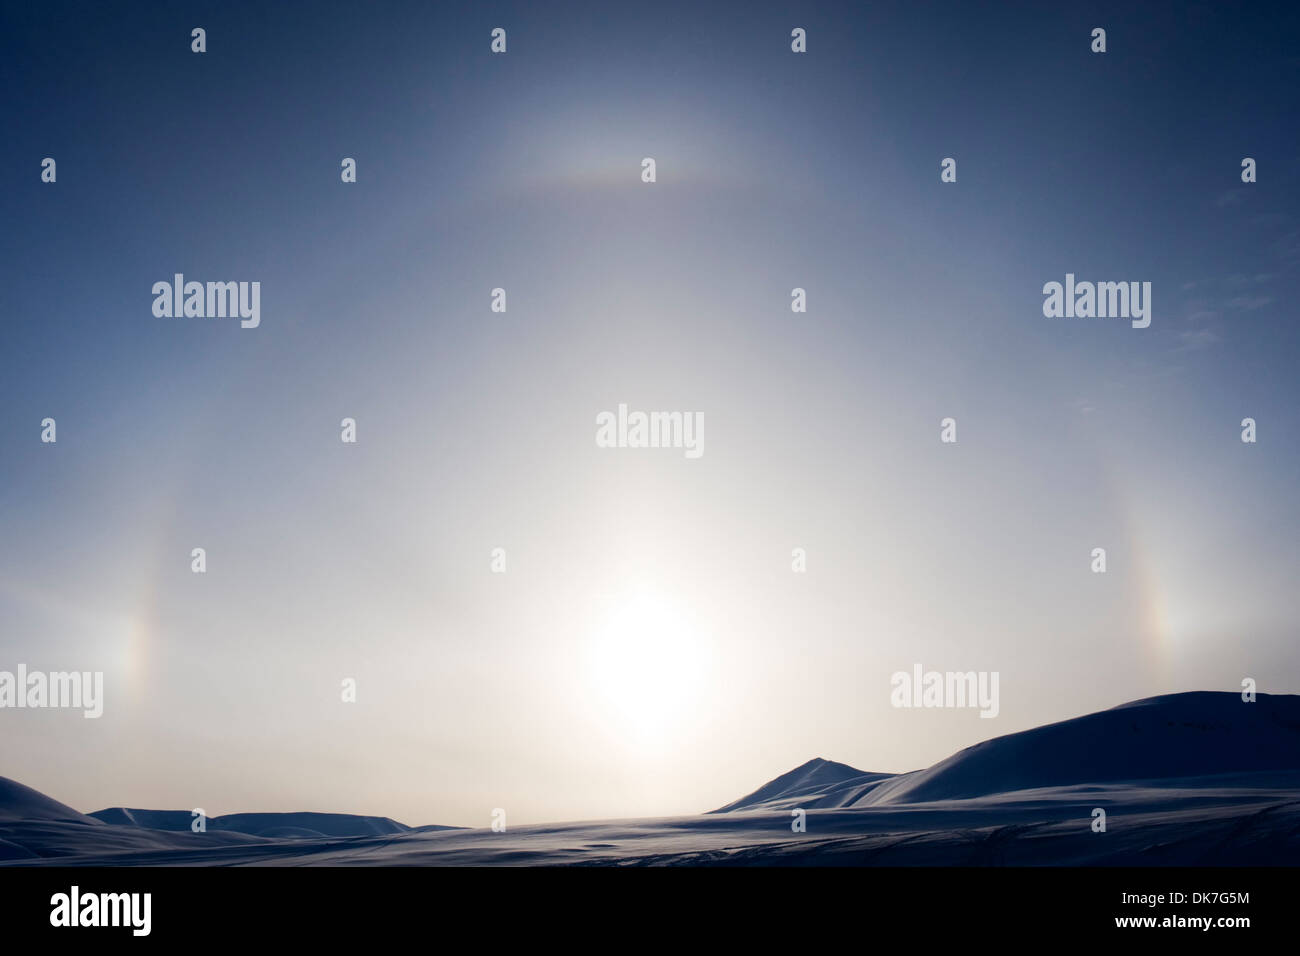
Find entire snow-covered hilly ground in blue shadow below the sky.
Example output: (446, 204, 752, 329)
(0, 693, 1300, 866)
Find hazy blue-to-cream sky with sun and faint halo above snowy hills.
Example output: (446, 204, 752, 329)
(0, 3, 1300, 826)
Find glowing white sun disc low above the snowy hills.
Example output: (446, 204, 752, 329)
(590, 589, 710, 747)
